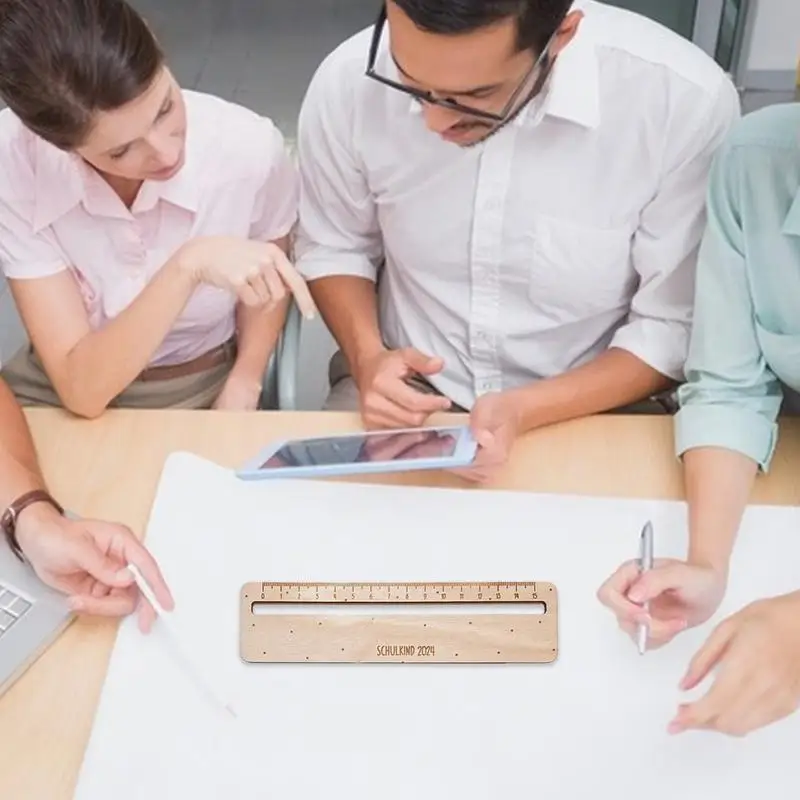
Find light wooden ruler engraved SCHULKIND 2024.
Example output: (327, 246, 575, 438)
(240, 582, 558, 664)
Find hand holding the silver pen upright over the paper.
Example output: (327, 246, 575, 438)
(597, 559, 727, 649)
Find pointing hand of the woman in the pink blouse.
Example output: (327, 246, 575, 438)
(177, 236, 316, 319)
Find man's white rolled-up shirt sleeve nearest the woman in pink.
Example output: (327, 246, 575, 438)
(295, 52, 383, 281)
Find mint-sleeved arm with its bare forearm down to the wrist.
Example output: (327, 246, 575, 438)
(675, 138, 783, 574)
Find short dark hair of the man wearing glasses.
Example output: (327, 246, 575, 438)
(392, 0, 572, 52)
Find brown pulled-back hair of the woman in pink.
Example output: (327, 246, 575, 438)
(0, 0, 164, 150)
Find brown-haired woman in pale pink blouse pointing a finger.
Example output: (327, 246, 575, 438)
(0, 0, 314, 417)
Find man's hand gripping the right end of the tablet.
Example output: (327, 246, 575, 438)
(453, 392, 521, 483)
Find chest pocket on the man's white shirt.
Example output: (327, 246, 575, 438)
(528, 216, 637, 321)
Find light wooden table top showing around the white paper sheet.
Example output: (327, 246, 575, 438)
(0, 409, 800, 800)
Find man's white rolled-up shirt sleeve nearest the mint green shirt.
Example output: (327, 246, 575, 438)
(611, 79, 740, 381)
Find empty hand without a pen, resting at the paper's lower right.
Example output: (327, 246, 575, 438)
(669, 593, 800, 736)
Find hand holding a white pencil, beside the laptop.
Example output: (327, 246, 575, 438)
(17, 504, 174, 633)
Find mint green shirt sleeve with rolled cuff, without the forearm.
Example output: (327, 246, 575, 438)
(675, 146, 783, 471)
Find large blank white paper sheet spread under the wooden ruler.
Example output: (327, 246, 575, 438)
(76, 453, 800, 800)
